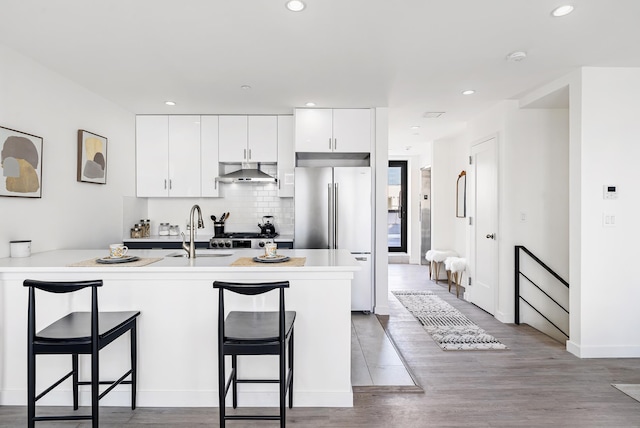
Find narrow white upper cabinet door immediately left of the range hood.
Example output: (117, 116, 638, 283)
(200, 116, 220, 197)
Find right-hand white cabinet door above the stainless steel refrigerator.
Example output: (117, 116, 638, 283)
(333, 109, 371, 153)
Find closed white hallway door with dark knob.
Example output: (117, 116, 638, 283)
(465, 138, 499, 315)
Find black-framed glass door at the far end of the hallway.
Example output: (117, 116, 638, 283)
(387, 161, 407, 253)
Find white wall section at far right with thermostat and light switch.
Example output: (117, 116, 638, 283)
(569, 68, 640, 357)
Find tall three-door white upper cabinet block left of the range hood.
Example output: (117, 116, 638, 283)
(136, 115, 218, 197)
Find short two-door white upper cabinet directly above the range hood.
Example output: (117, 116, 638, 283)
(218, 115, 278, 163)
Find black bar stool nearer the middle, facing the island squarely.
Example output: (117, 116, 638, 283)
(213, 281, 296, 427)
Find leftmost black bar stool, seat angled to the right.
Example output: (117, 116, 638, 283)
(24, 279, 140, 428)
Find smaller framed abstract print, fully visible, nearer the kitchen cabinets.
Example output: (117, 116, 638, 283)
(78, 129, 107, 184)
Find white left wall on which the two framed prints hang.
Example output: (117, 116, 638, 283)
(0, 46, 135, 257)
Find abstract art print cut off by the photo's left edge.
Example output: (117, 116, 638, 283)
(0, 126, 42, 198)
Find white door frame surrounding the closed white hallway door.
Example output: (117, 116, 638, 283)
(465, 133, 501, 317)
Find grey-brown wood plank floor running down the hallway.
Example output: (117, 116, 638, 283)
(5, 264, 640, 428)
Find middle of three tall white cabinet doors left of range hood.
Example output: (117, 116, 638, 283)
(169, 116, 200, 196)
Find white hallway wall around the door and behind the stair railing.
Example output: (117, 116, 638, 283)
(432, 101, 569, 328)
